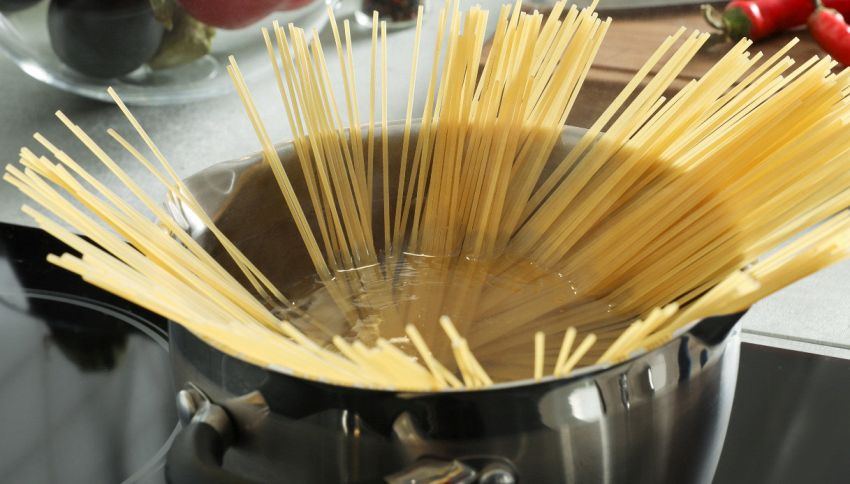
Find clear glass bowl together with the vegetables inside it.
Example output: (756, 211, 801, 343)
(0, 0, 337, 105)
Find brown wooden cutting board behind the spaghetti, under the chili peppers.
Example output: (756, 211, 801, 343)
(484, 5, 824, 127)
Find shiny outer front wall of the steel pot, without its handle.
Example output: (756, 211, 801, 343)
(171, 317, 740, 484)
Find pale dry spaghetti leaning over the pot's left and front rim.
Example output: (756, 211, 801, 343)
(4, 105, 492, 390)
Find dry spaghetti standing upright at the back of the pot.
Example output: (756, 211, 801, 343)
(229, 2, 610, 360)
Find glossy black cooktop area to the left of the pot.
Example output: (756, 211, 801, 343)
(0, 224, 177, 484)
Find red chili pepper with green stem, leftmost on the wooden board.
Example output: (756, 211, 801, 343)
(702, 0, 850, 40)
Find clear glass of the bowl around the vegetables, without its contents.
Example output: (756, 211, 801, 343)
(0, 0, 337, 105)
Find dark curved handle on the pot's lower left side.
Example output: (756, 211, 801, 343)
(165, 390, 254, 484)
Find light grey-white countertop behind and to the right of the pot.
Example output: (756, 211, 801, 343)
(0, 1, 850, 356)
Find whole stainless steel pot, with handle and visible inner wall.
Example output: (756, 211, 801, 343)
(162, 125, 740, 483)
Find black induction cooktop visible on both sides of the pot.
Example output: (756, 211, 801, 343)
(0, 223, 850, 484)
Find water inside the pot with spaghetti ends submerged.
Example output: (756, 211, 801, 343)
(276, 253, 623, 378)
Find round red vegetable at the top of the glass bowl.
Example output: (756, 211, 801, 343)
(178, 0, 312, 29)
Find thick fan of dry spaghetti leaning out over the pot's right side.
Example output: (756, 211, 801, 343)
(468, 46, 850, 370)
